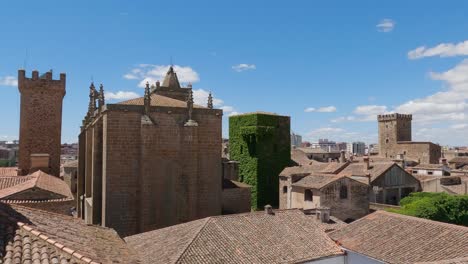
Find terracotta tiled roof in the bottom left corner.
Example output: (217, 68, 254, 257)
(0, 203, 137, 264)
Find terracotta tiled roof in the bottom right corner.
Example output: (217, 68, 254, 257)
(329, 211, 468, 263)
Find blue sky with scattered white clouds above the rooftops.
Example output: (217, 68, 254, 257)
(0, 1, 468, 145)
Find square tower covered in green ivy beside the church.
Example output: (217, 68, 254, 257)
(229, 112, 291, 209)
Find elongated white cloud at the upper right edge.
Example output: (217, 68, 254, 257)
(408, 40, 468, 60)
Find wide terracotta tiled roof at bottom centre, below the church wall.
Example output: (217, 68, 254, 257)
(125, 210, 343, 264)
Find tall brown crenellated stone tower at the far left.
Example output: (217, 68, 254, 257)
(18, 70, 65, 176)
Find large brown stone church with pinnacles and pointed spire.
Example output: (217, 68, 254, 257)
(77, 67, 229, 235)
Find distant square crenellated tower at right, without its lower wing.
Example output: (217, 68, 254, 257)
(378, 114, 412, 158)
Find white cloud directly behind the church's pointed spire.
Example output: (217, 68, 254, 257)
(123, 64, 200, 87)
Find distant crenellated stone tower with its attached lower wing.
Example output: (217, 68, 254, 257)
(377, 113, 442, 164)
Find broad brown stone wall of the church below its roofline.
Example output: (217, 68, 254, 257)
(95, 105, 222, 235)
